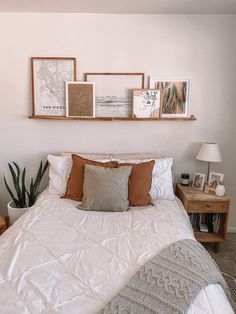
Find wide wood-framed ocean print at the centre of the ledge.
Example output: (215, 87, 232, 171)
(85, 72, 144, 118)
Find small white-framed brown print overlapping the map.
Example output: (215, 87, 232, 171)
(66, 82, 95, 118)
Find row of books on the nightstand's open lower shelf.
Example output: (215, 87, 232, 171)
(188, 213, 222, 233)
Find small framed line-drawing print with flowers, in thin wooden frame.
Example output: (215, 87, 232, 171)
(132, 89, 160, 119)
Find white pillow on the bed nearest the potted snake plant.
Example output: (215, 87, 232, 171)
(48, 155, 72, 195)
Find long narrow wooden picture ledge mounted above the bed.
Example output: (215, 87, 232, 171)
(29, 115, 197, 121)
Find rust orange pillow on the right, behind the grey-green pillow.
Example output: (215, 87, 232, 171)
(118, 160, 155, 206)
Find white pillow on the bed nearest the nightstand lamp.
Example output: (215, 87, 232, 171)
(117, 158, 175, 200)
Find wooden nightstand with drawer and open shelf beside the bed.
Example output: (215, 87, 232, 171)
(175, 183, 230, 253)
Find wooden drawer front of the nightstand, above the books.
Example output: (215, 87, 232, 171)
(186, 201, 229, 213)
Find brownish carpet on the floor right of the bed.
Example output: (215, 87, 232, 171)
(204, 233, 236, 312)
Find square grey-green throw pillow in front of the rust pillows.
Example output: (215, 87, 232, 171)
(78, 165, 132, 211)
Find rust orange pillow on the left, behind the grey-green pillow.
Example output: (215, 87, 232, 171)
(63, 154, 117, 201)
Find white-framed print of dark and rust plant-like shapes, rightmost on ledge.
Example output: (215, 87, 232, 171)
(149, 77, 190, 118)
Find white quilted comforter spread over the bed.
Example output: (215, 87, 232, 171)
(0, 191, 233, 314)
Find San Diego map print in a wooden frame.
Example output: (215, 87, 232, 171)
(31, 57, 76, 116)
